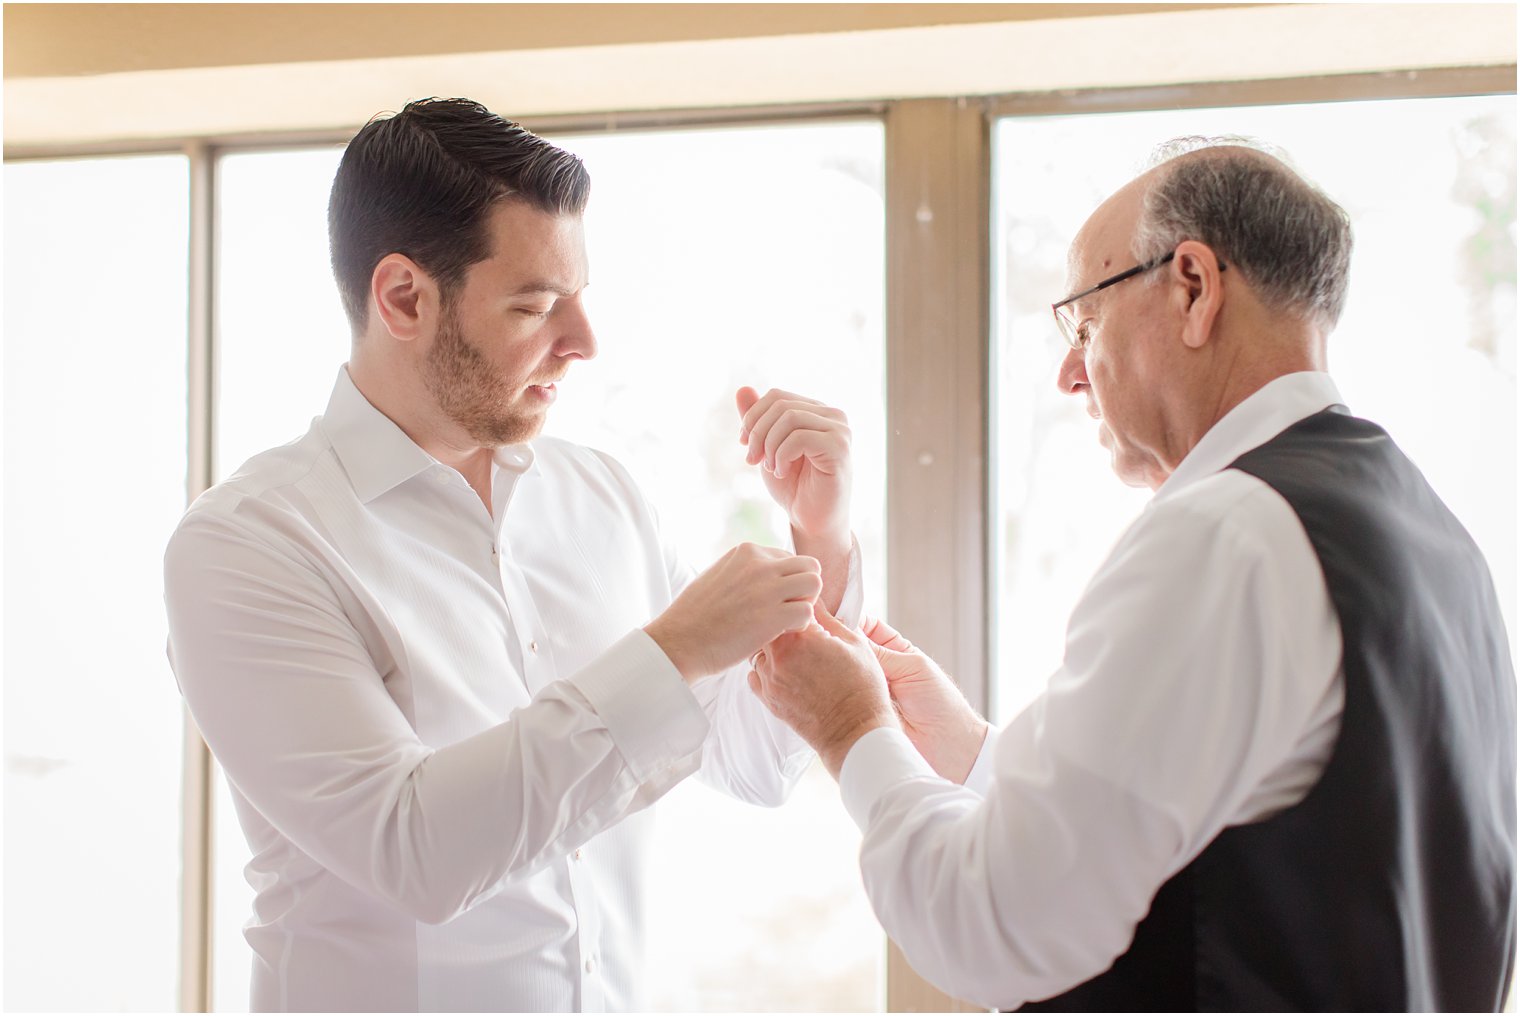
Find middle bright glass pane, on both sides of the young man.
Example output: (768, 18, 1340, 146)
(214, 123, 886, 1010)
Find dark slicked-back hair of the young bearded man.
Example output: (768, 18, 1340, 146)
(327, 99, 591, 335)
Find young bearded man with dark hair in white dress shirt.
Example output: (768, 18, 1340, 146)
(166, 100, 859, 1011)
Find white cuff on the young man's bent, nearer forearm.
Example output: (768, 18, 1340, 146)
(567, 628, 711, 783)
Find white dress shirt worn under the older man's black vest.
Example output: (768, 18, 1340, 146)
(841, 373, 1345, 1008)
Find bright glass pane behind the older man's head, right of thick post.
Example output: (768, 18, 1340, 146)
(994, 96, 1520, 721)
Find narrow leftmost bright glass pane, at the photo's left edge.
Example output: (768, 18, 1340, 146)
(5, 155, 188, 1010)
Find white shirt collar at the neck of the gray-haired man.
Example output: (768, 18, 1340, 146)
(1155, 371, 1345, 499)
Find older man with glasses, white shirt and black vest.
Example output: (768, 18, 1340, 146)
(751, 140, 1515, 1011)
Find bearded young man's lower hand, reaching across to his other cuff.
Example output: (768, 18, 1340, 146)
(644, 543, 822, 681)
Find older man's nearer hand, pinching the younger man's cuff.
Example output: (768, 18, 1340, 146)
(749, 610, 897, 779)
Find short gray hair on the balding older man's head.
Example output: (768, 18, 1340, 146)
(1132, 137, 1351, 330)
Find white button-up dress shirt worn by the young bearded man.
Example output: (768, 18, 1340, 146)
(166, 370, 860, 1011)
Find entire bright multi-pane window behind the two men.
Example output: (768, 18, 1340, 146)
(5, 67, 1517, 1011)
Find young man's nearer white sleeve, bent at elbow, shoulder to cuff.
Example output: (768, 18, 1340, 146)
(166, 519, 708, 923)
